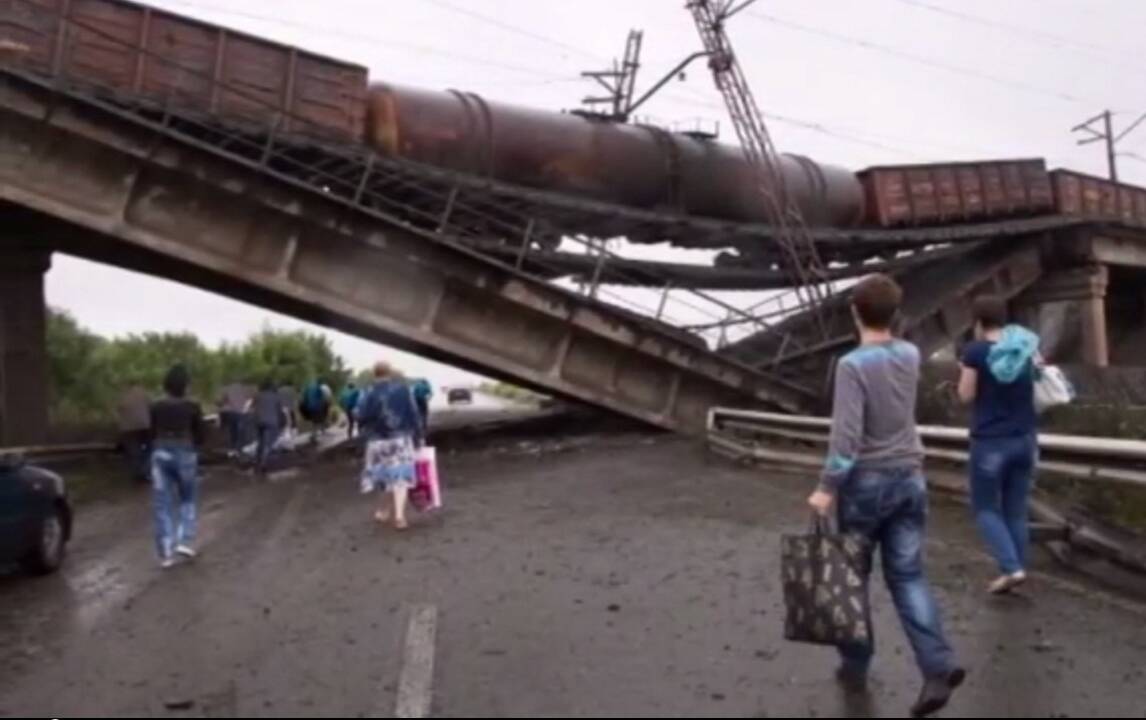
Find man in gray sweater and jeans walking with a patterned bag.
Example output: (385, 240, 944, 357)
(808, 275, 966, 718)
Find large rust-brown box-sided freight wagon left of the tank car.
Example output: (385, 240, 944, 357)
(0, 0, 367, 142)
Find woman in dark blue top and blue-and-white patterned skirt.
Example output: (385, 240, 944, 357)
(358, 362, 422, 530)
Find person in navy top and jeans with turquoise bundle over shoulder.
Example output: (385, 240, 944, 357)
(959, 296, 1041, 595)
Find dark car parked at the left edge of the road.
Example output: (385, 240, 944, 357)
(0, 456, 72, 574)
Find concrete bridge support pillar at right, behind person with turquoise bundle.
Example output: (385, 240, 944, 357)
(1018, 265, 1110, 367)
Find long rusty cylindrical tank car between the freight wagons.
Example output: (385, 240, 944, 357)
(367, 84, 864, 227)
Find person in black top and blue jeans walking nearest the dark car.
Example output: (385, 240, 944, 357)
(151, 365, 204, 569)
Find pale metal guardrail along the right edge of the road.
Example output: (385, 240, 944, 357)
(707, 407, 1146, 487)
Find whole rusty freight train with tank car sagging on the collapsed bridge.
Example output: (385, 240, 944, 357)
(0, 0, 1146, 241)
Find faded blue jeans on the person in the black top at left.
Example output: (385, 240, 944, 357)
(151, 445, 199, 559)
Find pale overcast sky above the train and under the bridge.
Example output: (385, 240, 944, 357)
(48, 0, 1146, 383)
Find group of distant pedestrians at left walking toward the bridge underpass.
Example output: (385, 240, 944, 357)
(116, 362, 432, 569)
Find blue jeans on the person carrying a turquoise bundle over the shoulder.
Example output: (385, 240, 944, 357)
(971, 435, 1038, 574)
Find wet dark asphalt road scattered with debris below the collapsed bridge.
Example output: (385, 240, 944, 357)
(0, 424, 1146, 718)
